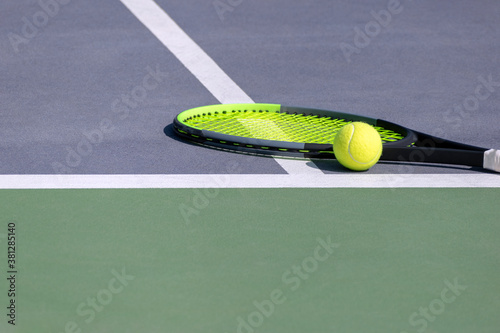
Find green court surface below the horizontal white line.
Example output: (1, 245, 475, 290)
(0, 189, 500, 333)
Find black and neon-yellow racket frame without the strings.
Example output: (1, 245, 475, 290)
(173, 103, 488, 167)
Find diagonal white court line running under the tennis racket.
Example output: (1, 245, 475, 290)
(117, 0, 323, 174)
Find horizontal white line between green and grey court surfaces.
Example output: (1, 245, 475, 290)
(0, 173, 500, 189)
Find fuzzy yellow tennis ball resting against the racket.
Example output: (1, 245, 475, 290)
(333, 122, 382, 171)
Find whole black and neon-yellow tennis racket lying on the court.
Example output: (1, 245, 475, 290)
(173, 103, 500, 172)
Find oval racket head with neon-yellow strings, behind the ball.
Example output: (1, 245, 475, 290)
(173, 103, 416, 158)
